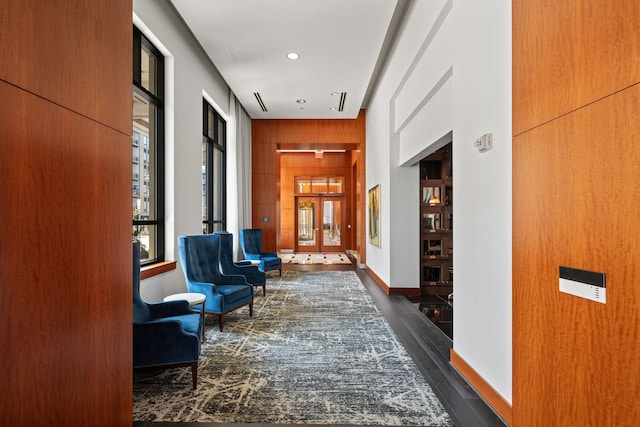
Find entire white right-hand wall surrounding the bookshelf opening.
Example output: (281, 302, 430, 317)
(367, 0, 511, 402)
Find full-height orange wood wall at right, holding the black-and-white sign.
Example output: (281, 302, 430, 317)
(513, 0, 640, 426)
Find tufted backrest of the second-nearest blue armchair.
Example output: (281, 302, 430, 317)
(178, 234, 228, 286)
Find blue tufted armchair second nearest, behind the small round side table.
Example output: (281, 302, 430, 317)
(178, 234, 253, 331)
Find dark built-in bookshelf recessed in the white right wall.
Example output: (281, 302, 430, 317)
(420, 143, 453, 295)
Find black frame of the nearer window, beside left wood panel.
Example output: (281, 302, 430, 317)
(132, 26, 165, 266)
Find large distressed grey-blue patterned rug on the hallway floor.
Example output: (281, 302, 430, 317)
(133, 271, 453, 426)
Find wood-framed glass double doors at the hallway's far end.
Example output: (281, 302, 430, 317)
(296, 197, 344, 252)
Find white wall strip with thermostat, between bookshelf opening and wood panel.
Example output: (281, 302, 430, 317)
(453, 0, 512, 402)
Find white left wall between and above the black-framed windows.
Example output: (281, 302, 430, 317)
(133, 0, 235, 301)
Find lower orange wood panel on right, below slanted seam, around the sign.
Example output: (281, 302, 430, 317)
(513, 85, 640, 426)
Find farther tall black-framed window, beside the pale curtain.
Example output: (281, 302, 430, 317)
(202, 100, 227, 234)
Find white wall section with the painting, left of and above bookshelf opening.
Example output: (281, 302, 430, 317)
(366, 0, 453, 288)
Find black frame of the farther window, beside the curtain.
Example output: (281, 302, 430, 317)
(202, 99, 227, 234)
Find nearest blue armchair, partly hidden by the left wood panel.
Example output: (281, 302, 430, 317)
(133, 243, 203, 389)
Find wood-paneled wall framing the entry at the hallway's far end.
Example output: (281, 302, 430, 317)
(251, 110, 366, 251)
